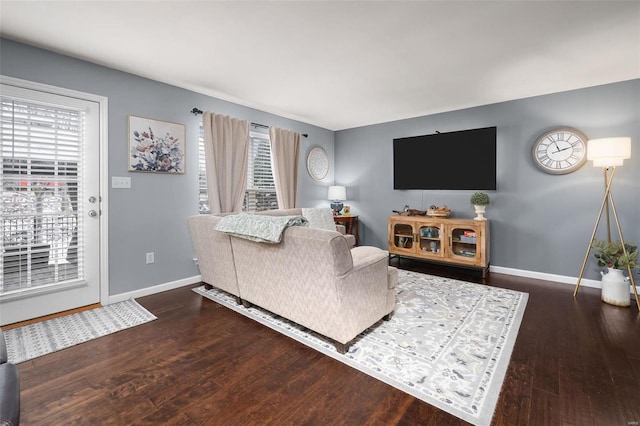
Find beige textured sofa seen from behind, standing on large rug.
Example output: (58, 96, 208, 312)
(188, 209, 398, 353)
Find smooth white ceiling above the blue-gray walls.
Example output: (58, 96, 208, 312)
(0, 0, 640, 130)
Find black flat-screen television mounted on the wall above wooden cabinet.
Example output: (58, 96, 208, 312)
(393, 127, 496, 190)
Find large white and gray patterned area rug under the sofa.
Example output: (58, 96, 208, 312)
(193, 270, 528, 425)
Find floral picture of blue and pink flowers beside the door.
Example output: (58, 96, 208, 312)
(129, 115, 186, 173)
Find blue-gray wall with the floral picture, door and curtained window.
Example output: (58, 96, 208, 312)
(0, 39, 334, 295)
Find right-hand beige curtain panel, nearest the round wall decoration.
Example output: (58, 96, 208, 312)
(269, 127, 300, 209)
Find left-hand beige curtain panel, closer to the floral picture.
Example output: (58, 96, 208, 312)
(202, 112, 249, 214)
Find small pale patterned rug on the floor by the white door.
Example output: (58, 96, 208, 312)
(4, 299, 157, 364)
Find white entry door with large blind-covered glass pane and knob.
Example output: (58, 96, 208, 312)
(0, 79, 102, 325)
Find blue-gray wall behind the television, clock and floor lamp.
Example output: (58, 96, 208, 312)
(335, 80, 640, 279)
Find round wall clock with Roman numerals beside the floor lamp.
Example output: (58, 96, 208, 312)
(531, 128, 587, 175)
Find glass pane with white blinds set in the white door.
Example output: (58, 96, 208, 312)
(0, 97, 84, 293)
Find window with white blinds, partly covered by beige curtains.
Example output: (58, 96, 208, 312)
(198, 126, 278, 214)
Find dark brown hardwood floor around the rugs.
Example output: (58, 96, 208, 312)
(10, 260, 640, 426)
